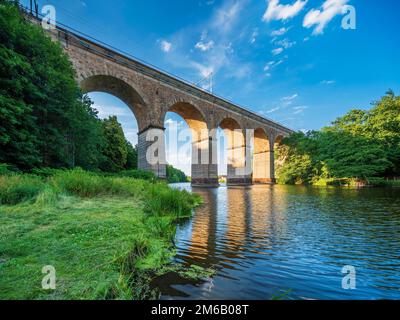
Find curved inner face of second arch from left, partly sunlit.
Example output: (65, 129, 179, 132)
(164, 102, 218, 186)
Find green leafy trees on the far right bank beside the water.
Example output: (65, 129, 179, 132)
(277, 92, 400, 185)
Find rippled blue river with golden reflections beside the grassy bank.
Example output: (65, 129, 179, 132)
(157, 184, 400, 299)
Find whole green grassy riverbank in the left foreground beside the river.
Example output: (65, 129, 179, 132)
(0, 170, 201, 299)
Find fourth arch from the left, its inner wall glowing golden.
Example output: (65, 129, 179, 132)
(253, 128, 271, 183)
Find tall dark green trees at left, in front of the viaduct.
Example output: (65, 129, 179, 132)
(0, 1, 106, 170)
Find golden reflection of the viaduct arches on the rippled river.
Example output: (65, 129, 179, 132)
(184, 186, 285, 269)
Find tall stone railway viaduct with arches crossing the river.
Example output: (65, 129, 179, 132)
(43, 20, 292, 186)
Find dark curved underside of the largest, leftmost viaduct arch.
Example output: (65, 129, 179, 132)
(80, 75, 147, 131)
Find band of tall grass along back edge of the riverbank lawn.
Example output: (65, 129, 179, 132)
(0, 169, 201, 217)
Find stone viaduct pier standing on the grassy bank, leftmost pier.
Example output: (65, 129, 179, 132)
(138, 126, 167, 179)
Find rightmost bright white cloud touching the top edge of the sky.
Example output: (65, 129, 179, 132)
(303, 0, 349, 35)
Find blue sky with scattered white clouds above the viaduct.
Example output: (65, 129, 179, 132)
(22, 0, 400, 175)
